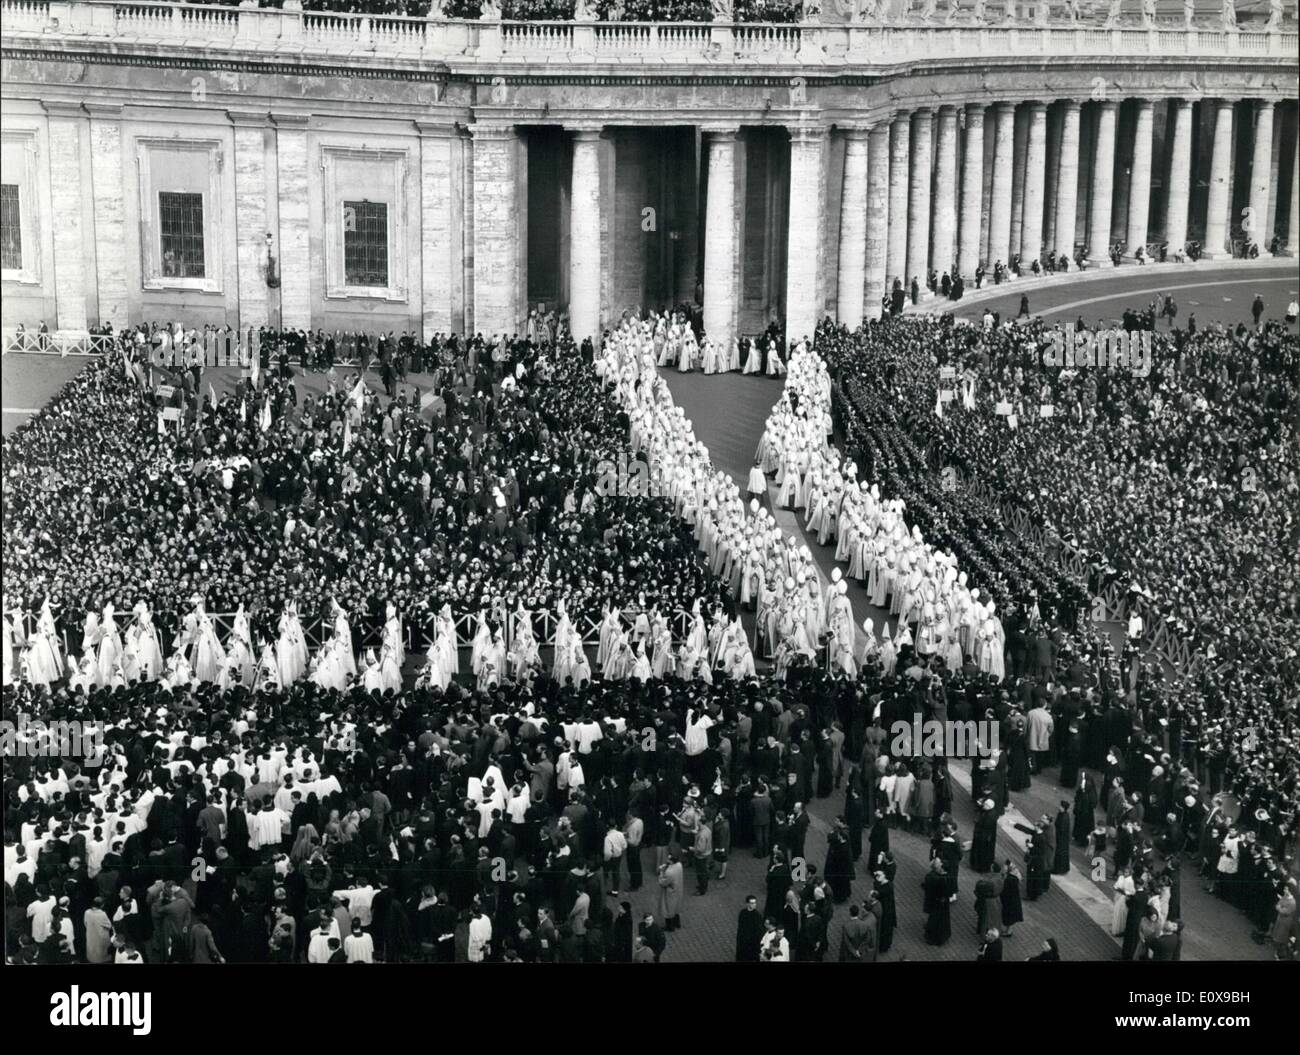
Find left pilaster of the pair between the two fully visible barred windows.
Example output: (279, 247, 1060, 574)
(226, 110, 271, 333)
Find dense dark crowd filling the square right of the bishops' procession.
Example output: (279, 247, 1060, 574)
(818, 313, 1300, 945)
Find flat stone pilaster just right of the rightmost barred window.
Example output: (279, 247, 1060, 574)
(416, 121, 460, 340)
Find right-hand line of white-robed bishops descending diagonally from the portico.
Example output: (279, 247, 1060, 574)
(754, 343, 1006, 681)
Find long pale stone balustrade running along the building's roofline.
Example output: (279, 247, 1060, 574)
(0, 0, 1297, 69)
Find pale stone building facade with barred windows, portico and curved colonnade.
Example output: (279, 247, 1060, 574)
(0, 0, 1300, 339)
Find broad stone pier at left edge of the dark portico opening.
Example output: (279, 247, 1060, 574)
(469, 125, 520, 338)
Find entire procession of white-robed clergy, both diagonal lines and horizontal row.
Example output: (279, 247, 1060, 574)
(3, 313, 1005, 693)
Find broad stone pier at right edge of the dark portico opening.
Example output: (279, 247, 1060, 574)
(785, 127, 826, 344)
